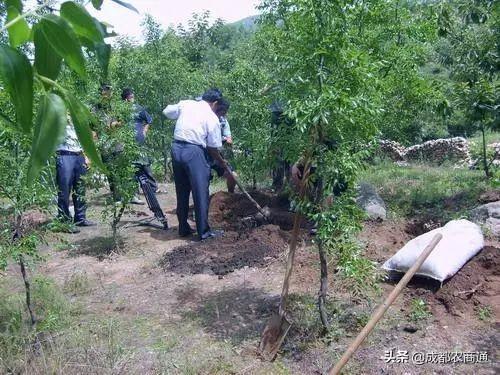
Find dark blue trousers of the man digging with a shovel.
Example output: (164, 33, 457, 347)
(172, 141, 210, 238)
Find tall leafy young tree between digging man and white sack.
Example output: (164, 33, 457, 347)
(262, 0, 381, 328)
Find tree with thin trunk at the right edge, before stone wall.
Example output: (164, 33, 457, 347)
(438, 0, 500, 178)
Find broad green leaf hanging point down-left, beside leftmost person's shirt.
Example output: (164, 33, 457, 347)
(28, 93, 68, 185)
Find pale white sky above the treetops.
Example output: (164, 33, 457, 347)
(87, 0, 259, 41)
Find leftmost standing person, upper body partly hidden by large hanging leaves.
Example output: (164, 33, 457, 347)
(56, 116, 96, 233)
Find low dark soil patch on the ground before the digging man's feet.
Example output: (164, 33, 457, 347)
(160, 225, 288, 275)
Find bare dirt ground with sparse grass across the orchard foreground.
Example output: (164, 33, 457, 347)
(4, 185, 500, 374)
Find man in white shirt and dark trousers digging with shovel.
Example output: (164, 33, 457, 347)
(163, 90, 226, 240)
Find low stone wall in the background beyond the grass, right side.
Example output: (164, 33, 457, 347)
(380, 137, 471, 165)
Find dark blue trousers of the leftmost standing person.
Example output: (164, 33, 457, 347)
(56, 154, 87, 222)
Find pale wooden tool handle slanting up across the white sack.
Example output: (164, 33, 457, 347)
(328, 233, 443, 375)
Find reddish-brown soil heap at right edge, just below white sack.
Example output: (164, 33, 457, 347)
(410, 246, 500, 316)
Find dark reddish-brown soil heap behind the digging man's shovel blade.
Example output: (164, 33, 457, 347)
(209, 191, 305, 231)
